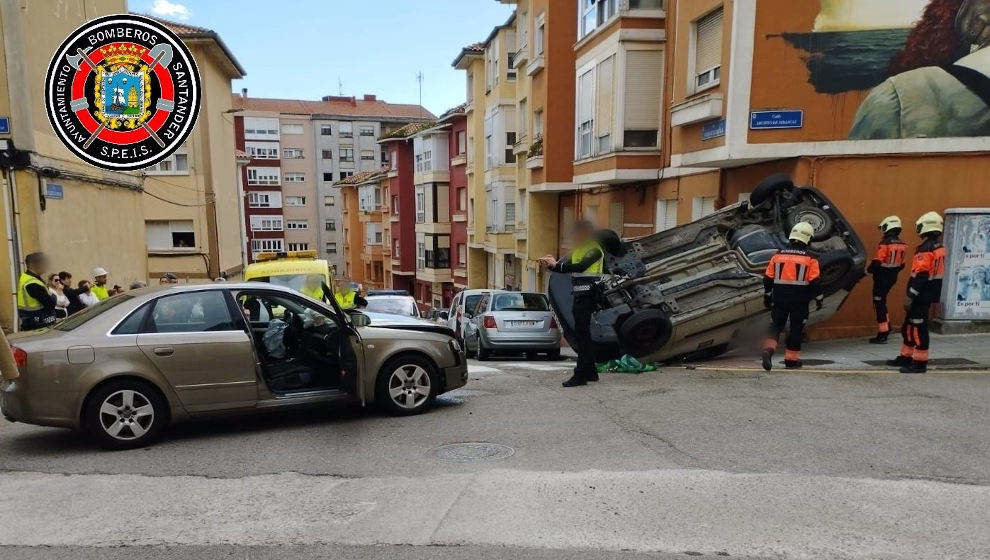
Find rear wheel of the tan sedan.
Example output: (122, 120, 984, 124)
(83, 379, 169, 449)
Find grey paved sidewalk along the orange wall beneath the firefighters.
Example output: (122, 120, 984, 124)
(561, 333, 990, 373)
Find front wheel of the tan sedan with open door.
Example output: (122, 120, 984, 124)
(375, 354, 440, 416)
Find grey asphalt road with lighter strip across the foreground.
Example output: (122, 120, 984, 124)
(0, 361, 990, 560)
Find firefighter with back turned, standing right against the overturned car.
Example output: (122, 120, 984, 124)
(762, 222, 824, 371)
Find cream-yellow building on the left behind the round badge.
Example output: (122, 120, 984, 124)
(0, 0, 244, 329)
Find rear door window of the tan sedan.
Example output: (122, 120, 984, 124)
(147, 290, 241, 333)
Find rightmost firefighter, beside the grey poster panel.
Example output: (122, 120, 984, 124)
(887, 212, 945, 373)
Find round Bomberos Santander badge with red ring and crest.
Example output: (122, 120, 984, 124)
(45, 14, 200, 171)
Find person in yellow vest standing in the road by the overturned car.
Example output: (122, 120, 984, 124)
(540, 220, 605, 387)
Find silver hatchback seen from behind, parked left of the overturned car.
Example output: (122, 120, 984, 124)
(464, 290, 560, 360)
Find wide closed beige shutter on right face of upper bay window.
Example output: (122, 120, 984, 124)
(625, 51, 663, 130)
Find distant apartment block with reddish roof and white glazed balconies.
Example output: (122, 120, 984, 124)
(234, 91, 433, 270)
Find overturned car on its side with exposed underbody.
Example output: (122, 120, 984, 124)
(549, 175, 868, 361)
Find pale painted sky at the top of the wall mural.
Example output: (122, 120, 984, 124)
(815, 0, 928, 31)
